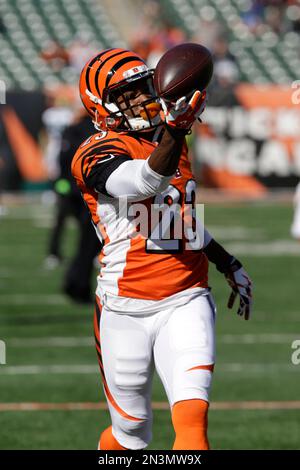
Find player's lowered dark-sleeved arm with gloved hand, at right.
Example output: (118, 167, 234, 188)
(203, 230, 252, 320)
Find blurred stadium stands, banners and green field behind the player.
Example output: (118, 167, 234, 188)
(0, 0, 300, 449)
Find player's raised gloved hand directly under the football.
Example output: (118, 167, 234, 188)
(160, 90, 206, 131)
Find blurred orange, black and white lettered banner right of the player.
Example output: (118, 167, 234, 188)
(194, 84, 300, 194)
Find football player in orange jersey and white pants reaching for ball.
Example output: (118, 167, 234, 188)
(72, 49, 251, 450)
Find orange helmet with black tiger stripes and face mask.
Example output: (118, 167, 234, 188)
(79, 49, 161, 131)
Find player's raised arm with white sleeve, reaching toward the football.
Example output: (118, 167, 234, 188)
(77, 87, 205, 201)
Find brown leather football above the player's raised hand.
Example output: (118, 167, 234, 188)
(154, 43, 213, 100)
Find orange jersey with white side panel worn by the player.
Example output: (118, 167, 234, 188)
(72, 131, 208, 300)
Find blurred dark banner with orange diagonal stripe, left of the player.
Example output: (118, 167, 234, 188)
(0, 85, 79, 192)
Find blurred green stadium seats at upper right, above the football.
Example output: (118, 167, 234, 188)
(161, 0, 300, 83)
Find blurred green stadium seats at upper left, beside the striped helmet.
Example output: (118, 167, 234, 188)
(0, 0, 124, 90)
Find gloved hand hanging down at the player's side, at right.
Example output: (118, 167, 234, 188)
(224, 259, 252, 320)
